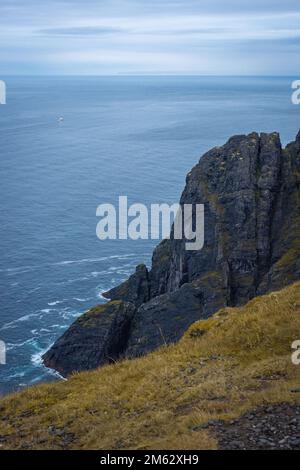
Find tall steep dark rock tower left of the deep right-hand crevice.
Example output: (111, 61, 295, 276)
(150, 133, 282, 305)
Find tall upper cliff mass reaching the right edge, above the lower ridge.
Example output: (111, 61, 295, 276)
(112, 132, 300, 310)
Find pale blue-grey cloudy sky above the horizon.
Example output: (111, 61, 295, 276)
(0, 0, 300, 76)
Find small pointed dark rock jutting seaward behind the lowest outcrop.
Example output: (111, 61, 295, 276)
(102, 264, 150, 306)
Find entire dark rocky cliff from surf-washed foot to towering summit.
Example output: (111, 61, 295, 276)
(44, 132, 300, 375)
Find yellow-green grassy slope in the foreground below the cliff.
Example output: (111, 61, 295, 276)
(0, 282, 300, 449)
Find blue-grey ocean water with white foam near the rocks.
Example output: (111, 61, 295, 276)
(0, 76, 300, 394)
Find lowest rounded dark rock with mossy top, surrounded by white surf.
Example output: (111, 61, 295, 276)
(43, 301, 135, 376)
